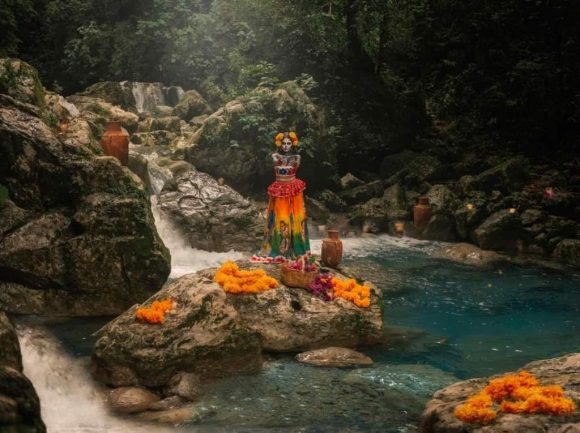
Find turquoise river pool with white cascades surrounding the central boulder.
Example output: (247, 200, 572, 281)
(19, 215, 580, 433)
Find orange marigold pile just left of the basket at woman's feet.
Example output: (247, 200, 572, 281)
(214, 261, 279, 293)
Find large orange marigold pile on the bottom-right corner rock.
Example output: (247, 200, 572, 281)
(455, 371, 576, 424)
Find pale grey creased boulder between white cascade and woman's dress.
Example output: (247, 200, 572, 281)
(158, 169, 264, 251)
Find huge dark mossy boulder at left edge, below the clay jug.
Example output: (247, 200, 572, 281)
(0, 85, 170, 315)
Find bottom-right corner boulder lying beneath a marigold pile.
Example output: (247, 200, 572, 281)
(421, 353, 580, 433)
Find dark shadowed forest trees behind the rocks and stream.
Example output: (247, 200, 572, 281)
(0, 0, 580, 178)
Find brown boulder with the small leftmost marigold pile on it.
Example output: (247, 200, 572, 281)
(93, 274, 262, 388)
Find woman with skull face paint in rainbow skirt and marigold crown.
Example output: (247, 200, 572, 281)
(252, 132, 310, 263)
